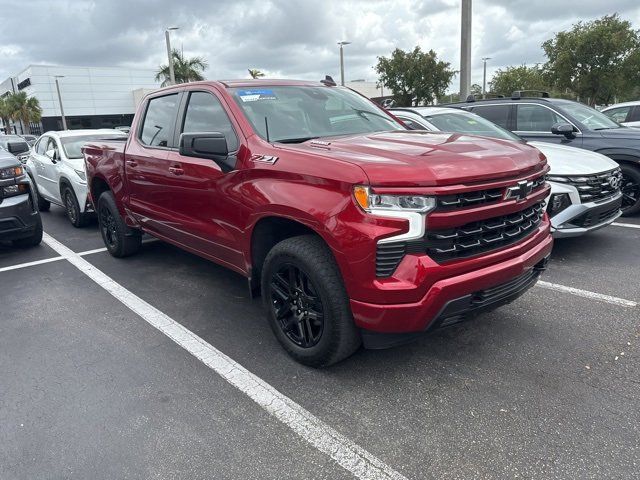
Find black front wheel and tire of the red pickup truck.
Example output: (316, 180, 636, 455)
(262, 235, 361, 367)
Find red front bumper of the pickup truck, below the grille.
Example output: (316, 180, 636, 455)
(351, 226, 553, 340)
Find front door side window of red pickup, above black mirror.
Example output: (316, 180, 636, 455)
(182, 92, 238, 152)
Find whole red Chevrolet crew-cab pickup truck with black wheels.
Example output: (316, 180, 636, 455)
(84, 80, 552, 366)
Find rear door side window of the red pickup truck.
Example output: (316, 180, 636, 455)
(140, 94, 178, 147)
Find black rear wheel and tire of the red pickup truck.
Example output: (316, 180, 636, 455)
(98, 191, 142, 258)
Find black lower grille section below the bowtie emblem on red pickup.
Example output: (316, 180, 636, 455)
(423, 202, 544, 262)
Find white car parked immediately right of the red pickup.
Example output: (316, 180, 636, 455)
(389, 107, 622, 238)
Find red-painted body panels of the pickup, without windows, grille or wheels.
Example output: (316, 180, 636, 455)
(84, 80, 552, 332)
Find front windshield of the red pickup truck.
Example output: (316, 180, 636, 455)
(231, 86, 405, 143)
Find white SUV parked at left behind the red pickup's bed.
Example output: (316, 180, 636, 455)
(26, 129, 127, 227)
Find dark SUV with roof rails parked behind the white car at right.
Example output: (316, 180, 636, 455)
(449, 92, 640, 215)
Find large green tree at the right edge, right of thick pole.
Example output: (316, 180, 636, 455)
(542, 14, 640, 105)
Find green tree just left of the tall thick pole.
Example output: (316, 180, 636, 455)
(374, 47, 456, 107)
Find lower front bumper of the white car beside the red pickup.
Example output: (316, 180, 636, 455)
(551, 193, 622, 238)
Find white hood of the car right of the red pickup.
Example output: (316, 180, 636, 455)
(527, 142, 618, 175)
